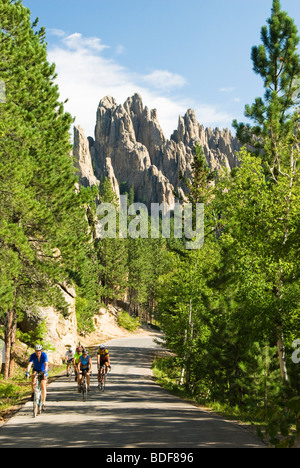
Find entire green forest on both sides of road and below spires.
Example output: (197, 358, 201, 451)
(0, 0, 300, 446)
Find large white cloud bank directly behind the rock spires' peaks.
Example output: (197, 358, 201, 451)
(48, 30, 231, 138)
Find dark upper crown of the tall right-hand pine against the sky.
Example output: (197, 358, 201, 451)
(233, 0, 300, 173)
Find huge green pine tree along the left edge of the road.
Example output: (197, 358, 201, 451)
(0, 0, 92, 378)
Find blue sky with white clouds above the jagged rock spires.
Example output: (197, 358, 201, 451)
(23, 0, 300, 138)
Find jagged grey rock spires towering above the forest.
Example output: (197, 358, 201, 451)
(74, 94, 240, 206)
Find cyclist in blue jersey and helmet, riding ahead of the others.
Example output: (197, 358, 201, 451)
(26, 344, 49, 411)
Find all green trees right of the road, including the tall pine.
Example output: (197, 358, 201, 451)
(157, 0, 300, 436)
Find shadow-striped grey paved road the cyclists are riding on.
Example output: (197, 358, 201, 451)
(0, 336, 265, 449)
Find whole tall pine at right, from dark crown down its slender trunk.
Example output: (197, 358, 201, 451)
(233, 0, 300, 380)
